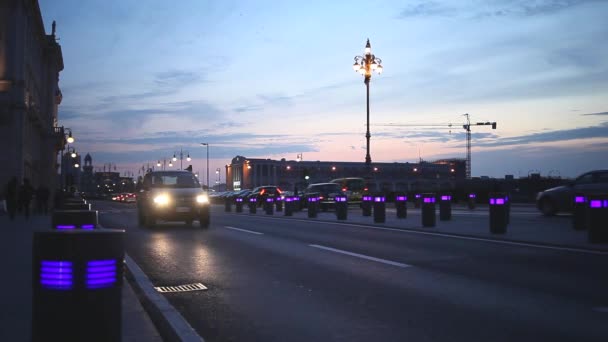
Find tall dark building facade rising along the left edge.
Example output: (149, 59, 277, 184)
(0, 0, 65, 189)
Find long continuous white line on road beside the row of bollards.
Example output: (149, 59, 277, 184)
(243, 216, 608, 255)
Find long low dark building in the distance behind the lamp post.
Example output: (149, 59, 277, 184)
(226, 156, 466, 191)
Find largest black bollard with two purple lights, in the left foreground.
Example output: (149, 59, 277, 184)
(31, 229, 125, 342)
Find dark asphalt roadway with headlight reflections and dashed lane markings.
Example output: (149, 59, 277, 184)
(95, 202, 608, 342)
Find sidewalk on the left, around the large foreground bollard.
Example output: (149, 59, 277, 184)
(0, 214, 162, 342)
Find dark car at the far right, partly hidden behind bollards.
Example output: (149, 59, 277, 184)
(536, 170, 608, 216)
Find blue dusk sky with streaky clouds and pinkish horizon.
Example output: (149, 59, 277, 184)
(39, 0, 608, 181)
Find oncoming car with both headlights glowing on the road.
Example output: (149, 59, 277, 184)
(137, 171, 209, 228)
